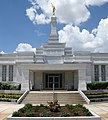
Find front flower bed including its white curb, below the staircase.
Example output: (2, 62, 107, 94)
(7, 103, 100, 120)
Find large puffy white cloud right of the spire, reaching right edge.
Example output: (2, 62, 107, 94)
(58, 18, 108, 52)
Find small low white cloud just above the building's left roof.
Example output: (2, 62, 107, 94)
(16, 43, 35, 52)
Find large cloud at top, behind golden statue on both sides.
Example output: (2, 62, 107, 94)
(26, 0, 90, 25)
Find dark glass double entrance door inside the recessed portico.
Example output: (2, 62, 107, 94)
(45, 74, 62, 89)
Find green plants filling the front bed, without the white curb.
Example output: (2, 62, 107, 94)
(12, 102, 92, 117)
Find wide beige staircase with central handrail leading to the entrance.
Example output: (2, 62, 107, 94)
(22, 91, 86, 105)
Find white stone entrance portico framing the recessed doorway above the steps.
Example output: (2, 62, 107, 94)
(22, 64, 86, 90)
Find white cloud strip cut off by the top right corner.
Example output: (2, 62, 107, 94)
(85, 0, 108, 6)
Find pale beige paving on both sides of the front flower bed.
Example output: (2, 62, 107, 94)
(0, 102, 108, 120)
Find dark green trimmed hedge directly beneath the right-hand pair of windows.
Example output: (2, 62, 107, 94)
(87, 82, 108, 90)
